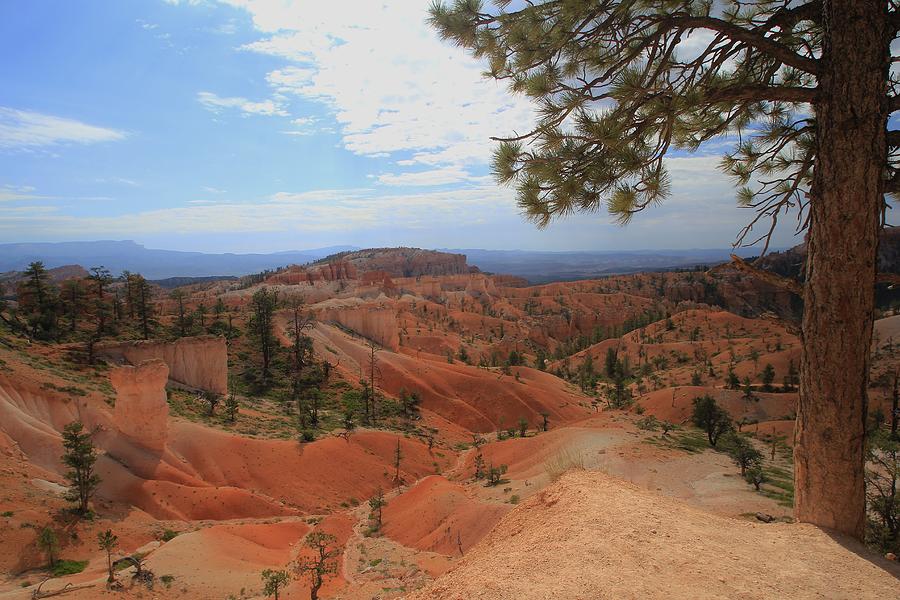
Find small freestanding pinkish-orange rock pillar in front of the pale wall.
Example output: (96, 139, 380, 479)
(109, 359, 169, 451)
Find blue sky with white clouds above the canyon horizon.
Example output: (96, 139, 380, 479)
(0, 0, 816, 252)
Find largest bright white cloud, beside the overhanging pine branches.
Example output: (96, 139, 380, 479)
(221, 0, 534, 168)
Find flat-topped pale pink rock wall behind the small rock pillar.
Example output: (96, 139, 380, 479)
(97, 336, 228, 394)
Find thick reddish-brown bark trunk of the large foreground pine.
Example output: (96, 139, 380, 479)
(794, 0, 890, 539)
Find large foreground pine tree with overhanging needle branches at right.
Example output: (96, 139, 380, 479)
(431, 0, 900, 539)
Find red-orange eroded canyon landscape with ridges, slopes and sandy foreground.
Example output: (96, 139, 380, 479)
(0, 249, 900, 600)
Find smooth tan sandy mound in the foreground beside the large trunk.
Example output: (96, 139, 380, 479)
(406, 472, 900, 600)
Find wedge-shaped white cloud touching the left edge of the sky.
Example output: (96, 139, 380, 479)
(0, 106, 126, 148)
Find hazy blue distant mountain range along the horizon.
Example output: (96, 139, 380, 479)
(0, 241, 768, 283)
